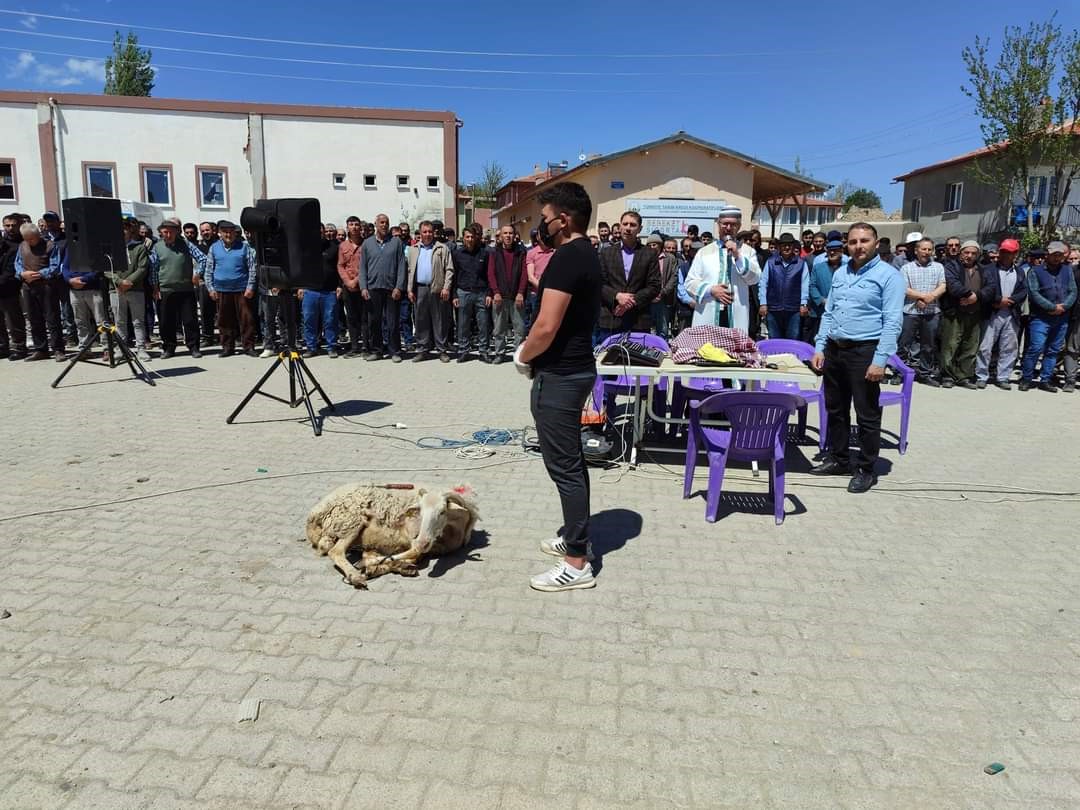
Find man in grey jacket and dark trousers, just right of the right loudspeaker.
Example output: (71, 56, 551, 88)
(360, 214, 406, 363)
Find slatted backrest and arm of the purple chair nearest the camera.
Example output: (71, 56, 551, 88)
(690, 391, 805, 461)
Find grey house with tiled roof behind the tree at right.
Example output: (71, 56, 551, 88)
(893, 130, 1080, 241)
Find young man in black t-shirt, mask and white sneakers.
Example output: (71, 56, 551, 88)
(514, 183, 602, 591)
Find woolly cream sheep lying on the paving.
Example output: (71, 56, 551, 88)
(307, 484, 480, 588)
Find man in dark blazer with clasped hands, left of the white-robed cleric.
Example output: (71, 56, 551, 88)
(594, 211, 661, 346)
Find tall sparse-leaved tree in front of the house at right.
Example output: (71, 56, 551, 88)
(961, 13, 1080, 239)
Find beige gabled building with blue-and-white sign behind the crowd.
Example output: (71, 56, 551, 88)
(491, 132, 827, 239)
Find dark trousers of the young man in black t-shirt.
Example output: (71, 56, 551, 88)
(530, 372, 596, 557)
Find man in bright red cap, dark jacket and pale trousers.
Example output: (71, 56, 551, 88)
(975, 239, 1027, 391)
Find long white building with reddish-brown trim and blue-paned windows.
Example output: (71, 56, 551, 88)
(0, 91, 460, 231)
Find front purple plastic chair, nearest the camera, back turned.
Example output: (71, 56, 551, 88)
(683, 391, 806, 526)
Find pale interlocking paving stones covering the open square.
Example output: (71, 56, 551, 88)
(0, 354, 1080, 810)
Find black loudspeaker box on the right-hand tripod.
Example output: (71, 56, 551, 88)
(240, 198, 323, 289)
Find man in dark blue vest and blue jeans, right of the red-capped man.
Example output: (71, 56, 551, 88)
(1020, 242, 1077, 393)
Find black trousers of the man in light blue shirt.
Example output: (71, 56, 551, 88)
(824, 340, 881, 473)
